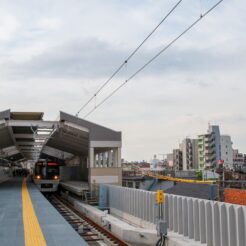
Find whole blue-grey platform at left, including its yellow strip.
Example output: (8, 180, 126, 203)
(0, 178, 88, 246)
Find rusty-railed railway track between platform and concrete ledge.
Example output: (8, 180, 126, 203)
(48, 195, 129, 246)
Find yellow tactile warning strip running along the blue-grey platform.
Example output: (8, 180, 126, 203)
(22, 179, 46, 246)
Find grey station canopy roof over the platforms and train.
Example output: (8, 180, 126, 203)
(0, 110, 121, 161)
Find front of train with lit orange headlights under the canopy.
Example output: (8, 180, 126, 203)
(34, 161, 60, 192)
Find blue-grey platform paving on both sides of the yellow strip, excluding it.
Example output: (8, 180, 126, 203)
(0, 179, 88, 246)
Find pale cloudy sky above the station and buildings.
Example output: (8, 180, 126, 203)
(0, 0, 246, 161)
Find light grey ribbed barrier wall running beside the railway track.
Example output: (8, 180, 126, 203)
(104, 185, 246, 246)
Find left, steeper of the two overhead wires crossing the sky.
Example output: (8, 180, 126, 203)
(76, 0, 183, 116)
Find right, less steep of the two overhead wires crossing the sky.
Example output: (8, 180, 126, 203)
(84, 0, 224, 118)
